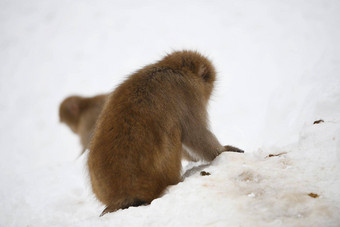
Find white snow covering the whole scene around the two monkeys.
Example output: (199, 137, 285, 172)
(0, 0, 340, 226)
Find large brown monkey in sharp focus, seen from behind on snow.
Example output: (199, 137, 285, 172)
(88, 51, 243, 215)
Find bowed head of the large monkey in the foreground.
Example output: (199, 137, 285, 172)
(159, 50, 216, 101)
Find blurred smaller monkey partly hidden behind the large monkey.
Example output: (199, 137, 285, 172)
(59, 95, 107, 153)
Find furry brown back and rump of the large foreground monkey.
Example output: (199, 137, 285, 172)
(88, 65, 195, 210)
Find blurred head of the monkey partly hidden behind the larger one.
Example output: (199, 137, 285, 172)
(59, 96, 83, 133)
